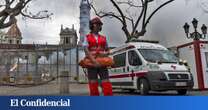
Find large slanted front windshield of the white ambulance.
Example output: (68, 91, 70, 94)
(138, 49, 178, 63)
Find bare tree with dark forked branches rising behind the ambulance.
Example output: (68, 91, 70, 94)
(90, 0, 175, 42)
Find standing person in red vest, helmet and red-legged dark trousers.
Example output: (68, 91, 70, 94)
(83, 17, 113, 96)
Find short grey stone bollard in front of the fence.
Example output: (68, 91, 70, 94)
(59, 71, 70, 94)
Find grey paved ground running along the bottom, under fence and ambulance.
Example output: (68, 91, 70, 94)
(0, 81, 208, 96)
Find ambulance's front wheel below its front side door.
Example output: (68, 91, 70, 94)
(139, 79, 149, 95)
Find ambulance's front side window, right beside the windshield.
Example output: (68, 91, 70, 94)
(128, 50, 142, 66)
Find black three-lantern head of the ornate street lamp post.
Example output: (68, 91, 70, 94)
(183, 18, 207, 40)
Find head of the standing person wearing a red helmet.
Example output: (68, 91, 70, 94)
(89, 17, 103, 32)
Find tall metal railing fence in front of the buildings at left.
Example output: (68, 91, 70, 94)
(0, 45, 78, 85)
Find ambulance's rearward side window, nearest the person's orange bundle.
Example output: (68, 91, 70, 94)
(113, 53, 126, 67)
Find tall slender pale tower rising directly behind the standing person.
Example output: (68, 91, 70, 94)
(79, 0, 91, 44)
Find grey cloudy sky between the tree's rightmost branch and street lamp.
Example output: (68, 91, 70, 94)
(145, 0, 208, 47)
